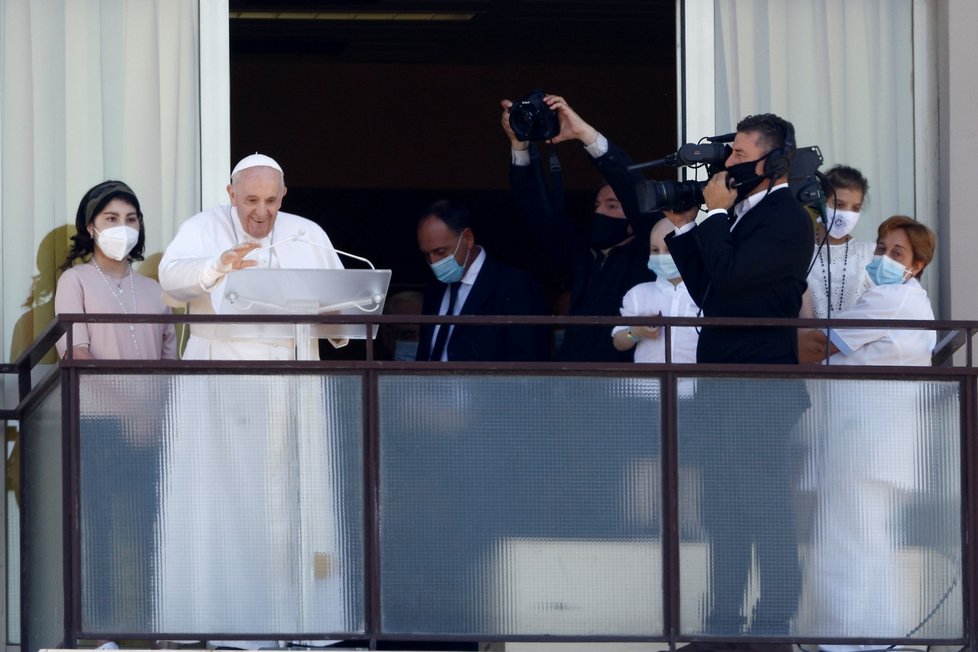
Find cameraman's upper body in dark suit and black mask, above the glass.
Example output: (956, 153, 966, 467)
(666, 113, 814, 364)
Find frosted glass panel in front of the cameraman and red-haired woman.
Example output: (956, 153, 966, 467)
(679, 378, 963, 638)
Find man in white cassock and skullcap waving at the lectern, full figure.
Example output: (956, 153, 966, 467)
(155, 154, 355, 648)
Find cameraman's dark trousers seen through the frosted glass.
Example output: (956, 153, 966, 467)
(680, 378, 808, 635)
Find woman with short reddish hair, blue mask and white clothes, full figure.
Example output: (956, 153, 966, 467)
(803, 216, 936, 652)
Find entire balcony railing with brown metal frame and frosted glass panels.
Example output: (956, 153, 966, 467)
(3, 315, 978, 652)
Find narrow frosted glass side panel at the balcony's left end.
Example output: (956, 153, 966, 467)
(21, 385, 65, 650)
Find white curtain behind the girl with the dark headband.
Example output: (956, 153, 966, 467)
(0, 0, 200, 360)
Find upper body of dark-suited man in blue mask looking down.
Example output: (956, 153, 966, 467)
(417, 200, 549, 361)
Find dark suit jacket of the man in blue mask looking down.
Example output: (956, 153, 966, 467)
(416, 255, 550, 361)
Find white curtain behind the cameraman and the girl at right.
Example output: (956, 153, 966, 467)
(714, 0, 924, 292)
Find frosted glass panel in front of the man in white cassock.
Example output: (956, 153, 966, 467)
(80, 375, 364, 635)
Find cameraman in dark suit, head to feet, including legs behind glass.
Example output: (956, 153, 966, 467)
(666, 114, 814, 636)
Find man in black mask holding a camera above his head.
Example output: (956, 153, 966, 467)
(501, 92, 661, 361)
